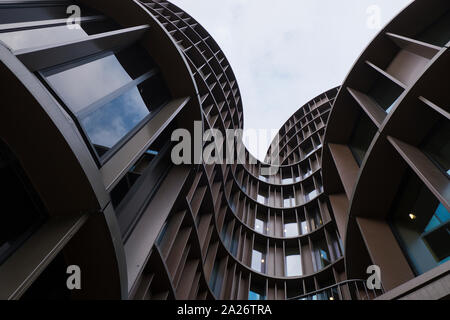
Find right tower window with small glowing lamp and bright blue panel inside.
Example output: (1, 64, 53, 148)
(391, 171, 450, 275)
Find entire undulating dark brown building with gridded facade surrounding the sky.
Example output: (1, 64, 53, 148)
(0, 0, 450, 300)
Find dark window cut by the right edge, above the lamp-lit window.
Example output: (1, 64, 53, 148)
(422, 119, 450, 177)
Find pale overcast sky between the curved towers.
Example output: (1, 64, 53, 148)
(171, 0, 412, 159)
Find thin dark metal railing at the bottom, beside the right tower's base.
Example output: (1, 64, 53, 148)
(289, 279, 384, 300)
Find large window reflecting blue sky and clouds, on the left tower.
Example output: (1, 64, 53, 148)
(42, 46, 170, 157)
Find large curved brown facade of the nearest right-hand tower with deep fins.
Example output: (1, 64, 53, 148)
(322, 0, 450, 299)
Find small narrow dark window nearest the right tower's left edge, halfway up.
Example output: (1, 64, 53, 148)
(349, 113, 377, 166)
